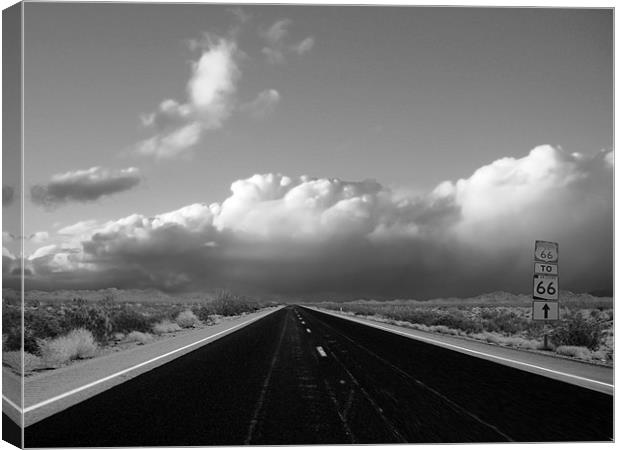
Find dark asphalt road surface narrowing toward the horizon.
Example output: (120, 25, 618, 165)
(25, 307, 613, 447)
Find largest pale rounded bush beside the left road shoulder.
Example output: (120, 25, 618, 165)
(39, 328, 97, 365)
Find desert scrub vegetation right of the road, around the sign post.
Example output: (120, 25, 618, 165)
(315, 293, 614, 364)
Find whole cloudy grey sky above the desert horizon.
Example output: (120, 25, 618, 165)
(3, 3, 614, 298)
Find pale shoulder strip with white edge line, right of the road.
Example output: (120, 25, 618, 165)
(308, 307, 614, 394)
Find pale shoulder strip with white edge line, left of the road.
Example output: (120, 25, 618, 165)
(12, 308, 279, 426)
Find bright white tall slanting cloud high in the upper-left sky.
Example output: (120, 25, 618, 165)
(135, 34, 242, 159)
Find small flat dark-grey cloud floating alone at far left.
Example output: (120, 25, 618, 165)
(30, 167, 141, 207)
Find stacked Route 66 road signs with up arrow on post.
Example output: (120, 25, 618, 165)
(532, 241, 560, 350)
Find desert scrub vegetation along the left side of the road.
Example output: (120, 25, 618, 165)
(2, 290, 265, 374)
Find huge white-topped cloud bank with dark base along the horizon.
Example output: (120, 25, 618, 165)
(21, 146, 613, 298)
